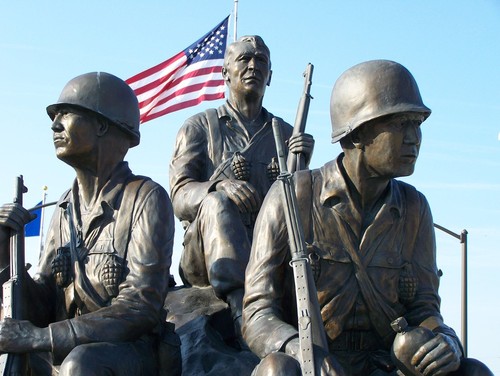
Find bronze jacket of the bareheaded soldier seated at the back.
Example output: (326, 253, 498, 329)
(169, 103, 292, 224)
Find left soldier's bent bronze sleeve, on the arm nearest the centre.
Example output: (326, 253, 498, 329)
(49, 185, 174, 360)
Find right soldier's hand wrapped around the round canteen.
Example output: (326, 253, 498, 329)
(411, 333, 461, 376)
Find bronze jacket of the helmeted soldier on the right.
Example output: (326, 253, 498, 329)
(243, 156, 458, 358)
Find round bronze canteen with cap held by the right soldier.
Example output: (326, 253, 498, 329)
(391, 317, 435, 376)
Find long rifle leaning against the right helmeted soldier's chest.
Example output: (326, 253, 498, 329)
(272, 118, 328, 376)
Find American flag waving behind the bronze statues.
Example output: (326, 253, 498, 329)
(126, 16, 229, 123)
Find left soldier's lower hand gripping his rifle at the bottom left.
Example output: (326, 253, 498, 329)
(0, 318, 51, 353)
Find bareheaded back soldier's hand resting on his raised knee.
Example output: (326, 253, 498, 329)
(216, 179, 261, 213)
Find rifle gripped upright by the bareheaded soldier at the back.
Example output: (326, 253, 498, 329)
(288, 63, 314, 173)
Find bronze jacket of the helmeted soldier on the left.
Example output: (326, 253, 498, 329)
(28, 162, 174, 361)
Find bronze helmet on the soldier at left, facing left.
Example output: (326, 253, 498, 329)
(47, 72, 141, 147)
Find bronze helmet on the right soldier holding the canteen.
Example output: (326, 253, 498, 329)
(330, 60, 431, 143)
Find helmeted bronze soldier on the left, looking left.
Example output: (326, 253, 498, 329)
(0, 72, 180, 376)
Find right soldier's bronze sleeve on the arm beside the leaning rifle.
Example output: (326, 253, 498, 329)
(242, 182, 297, 358)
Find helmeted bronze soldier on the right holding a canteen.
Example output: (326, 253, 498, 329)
(243, 60, 492, 376)
